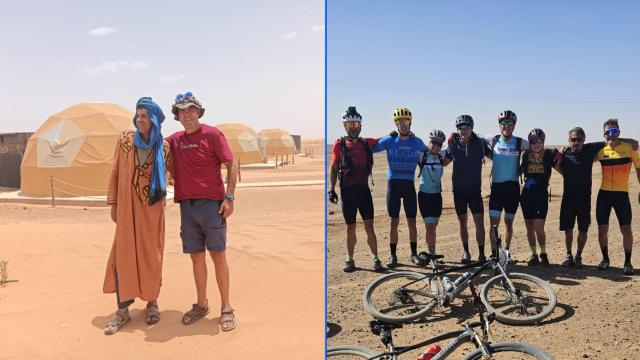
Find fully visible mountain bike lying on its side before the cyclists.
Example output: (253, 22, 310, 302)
(363, 226, 557, 325)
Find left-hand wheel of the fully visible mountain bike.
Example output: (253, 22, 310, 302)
(363, 272, 438, 324)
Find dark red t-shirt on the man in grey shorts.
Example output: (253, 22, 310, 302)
(166, 124, 233, 202)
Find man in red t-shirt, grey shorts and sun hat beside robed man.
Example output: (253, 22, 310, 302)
(167, 92, 238, 331)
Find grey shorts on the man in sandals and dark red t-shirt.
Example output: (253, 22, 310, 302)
(180, 199, 227, 254)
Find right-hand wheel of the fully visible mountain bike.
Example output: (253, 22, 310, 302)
(480, 273, 557, 325)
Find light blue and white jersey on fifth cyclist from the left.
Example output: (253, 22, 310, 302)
(487, 136, 529, 183)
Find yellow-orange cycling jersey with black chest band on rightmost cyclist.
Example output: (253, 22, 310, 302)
(593, 143, 640, 192)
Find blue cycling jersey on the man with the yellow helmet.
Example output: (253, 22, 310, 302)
(371, 136, 426, 180)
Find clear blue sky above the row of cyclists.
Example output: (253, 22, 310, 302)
(327, 0, 640, 144)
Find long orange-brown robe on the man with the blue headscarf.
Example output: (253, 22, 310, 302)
(102, 134, 172, 301)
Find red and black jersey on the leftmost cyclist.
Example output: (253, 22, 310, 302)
(331, 138, 380, 187)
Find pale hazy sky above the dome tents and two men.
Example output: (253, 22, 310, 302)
(0, 0, 324, 138)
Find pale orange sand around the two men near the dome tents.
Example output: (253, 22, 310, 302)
(0, 157, 324, 359)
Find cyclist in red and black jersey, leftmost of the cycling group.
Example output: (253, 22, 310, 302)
(329, 106, 384, 272)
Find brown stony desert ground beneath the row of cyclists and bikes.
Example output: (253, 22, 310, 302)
(327, 154, 640, 359)
